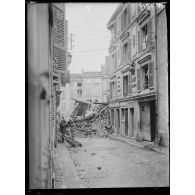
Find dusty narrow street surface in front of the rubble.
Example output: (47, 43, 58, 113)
(71, 138, 169, 188)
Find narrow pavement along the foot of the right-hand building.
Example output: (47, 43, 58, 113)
(108, 134, 169, 155)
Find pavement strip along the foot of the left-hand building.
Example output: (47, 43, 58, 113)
(54, 143, 79, 189)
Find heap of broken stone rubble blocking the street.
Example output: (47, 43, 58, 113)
(56, 105, 112, 148)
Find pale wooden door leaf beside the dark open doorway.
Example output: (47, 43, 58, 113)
(141, 103, 151, 141)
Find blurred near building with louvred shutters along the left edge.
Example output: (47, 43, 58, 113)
(27, 3, 68, 189)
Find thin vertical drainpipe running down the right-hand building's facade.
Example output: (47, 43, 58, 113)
(154, 3, 159, 138)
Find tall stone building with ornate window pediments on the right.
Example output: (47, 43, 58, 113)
(107, 3, 168, 145)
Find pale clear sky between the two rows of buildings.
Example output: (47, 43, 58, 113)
(66, 3, 119, 73)
